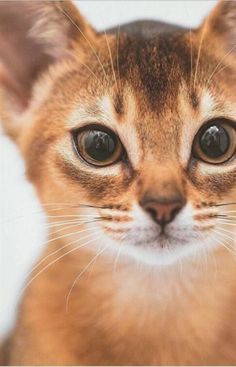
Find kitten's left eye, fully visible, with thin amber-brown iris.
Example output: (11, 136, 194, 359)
(74, 126, 124, 167)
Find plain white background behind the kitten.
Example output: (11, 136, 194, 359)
(0, 1, 216, 335)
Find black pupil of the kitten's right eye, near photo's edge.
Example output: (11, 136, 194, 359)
(200, 125, 230, 159)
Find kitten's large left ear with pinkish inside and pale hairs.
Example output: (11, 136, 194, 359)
(0, 0, 96, 129)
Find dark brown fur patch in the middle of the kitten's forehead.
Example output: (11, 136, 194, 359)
(116, 32, 191, 114)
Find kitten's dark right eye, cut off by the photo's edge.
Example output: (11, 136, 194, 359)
(193, 119, 236, 164)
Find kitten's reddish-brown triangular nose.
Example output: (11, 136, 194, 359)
(142, 199, 184, 228)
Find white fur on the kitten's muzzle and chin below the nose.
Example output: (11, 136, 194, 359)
(89, 204, 223, 267)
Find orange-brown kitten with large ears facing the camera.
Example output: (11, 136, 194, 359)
(0, 1, 236, 365)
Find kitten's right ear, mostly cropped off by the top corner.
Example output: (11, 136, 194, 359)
(203, 0, 236, 55)
